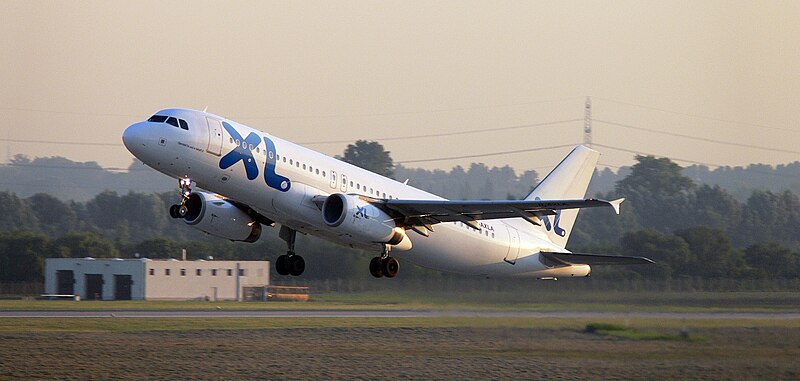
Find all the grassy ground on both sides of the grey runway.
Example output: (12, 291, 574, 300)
(0, 292, 800, 380)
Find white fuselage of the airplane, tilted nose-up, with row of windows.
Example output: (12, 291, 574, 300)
(123, 109, 590, 277)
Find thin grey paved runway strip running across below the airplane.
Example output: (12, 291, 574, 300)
(0, 309, 800, 320)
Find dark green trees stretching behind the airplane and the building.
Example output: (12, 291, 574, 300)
(0, 142, 800, 282)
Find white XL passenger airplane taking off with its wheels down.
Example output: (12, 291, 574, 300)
(122, 108, 653, 279)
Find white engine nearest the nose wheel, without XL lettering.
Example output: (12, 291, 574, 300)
(183, 192, 261, 242)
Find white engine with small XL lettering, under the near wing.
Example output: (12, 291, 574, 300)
(322, 193, 411, 251)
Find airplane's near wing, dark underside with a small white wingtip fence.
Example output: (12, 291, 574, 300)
(382, 198, 625, 230)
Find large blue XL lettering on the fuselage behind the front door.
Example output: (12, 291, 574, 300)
(219, 122, 292, 192)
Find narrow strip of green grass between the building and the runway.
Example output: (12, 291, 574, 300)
(0, 291, 800, 312)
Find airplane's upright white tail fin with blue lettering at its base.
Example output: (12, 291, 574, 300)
(525, 146, 600, 247)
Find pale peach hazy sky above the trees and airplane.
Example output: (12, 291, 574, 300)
(0, 0, 800, 172)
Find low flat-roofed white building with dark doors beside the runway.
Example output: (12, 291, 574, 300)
(44, 258, 269, 300)
